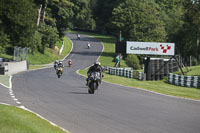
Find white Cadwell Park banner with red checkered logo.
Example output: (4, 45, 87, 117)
(126, 41, 175, 55)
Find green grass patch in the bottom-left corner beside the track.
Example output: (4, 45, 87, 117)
(0, 105, 68, 133)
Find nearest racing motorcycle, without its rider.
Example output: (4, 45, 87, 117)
(88, 72, 101, 94)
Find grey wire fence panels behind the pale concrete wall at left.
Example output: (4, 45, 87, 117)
(14, 46, 28, 61)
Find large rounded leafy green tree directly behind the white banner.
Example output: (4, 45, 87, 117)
(112, 0, 166, 42)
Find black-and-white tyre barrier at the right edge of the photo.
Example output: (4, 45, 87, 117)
(168, 73, 200, 88)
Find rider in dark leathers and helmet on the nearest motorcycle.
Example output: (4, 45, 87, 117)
(86, 61, 103, 86)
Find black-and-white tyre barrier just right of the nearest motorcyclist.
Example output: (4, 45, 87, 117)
(108, 67, 144, 80)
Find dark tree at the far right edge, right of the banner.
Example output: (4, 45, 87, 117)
(176, 0, 200, 58)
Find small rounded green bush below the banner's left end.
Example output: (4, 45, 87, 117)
(126, 54, 140, 70)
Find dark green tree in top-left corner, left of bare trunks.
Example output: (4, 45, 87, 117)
(0, 0, 37, 52)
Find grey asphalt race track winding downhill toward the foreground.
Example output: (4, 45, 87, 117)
(1, 33, 200, 133)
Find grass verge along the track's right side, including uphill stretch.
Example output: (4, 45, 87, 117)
(74, 32, 200, 100)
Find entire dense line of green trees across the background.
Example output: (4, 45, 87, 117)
(0, 0, 200, 62)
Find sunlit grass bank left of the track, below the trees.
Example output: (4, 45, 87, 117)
(28, 37, 72, 65)
